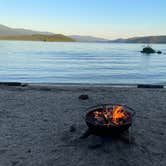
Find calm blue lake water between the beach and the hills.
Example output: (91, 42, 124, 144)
(0, 41, 166, 84)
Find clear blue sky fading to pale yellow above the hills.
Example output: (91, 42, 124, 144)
(0, 0, 166, 39)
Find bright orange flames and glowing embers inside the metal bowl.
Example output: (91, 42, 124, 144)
(93, 106, 130, 126)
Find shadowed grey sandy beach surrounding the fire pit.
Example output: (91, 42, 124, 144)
(0, 85, 166, 166)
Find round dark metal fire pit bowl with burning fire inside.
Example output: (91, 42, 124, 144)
(85, 104, 135, 135)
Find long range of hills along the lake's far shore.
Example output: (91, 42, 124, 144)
(0, 24, 166, 44)
